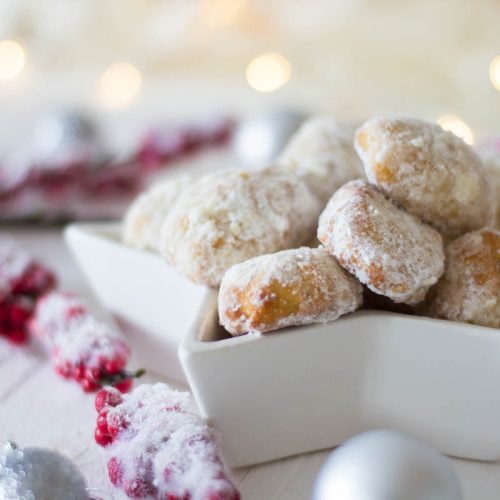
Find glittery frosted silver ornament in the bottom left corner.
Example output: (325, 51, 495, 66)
(0, 443, 89, 500)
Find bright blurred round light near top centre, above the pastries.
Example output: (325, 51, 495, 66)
(246, 52, 292, 92)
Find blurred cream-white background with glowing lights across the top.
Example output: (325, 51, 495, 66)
(0, 0, 500, 150)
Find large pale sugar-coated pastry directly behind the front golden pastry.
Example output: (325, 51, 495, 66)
(160, 168, 319, 286)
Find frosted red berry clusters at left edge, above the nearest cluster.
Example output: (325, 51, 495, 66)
(0, 238, 144, 392)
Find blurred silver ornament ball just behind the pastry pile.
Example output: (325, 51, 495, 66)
(232, 111, 307, 167)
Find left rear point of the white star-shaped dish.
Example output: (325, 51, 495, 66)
(65, 223, 208, 383)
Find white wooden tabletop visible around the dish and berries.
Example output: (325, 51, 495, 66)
(0, 228, 500, 500)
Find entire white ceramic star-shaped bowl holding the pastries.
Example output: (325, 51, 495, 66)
(67, 225, 500, 466)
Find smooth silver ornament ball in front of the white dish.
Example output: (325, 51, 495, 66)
(313, 430, 462, 500)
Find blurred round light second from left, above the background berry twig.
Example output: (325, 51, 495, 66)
(99, 62, 142, 107)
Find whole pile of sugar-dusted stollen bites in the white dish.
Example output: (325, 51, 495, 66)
(123, 117, 500, 335)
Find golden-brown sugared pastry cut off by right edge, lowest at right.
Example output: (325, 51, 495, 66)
(426, 229, 500, 328)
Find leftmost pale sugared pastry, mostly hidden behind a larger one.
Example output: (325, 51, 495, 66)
(122, 176, 193, 251)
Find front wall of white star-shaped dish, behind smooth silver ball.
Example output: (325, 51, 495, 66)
(179, 292, 500, 466)
